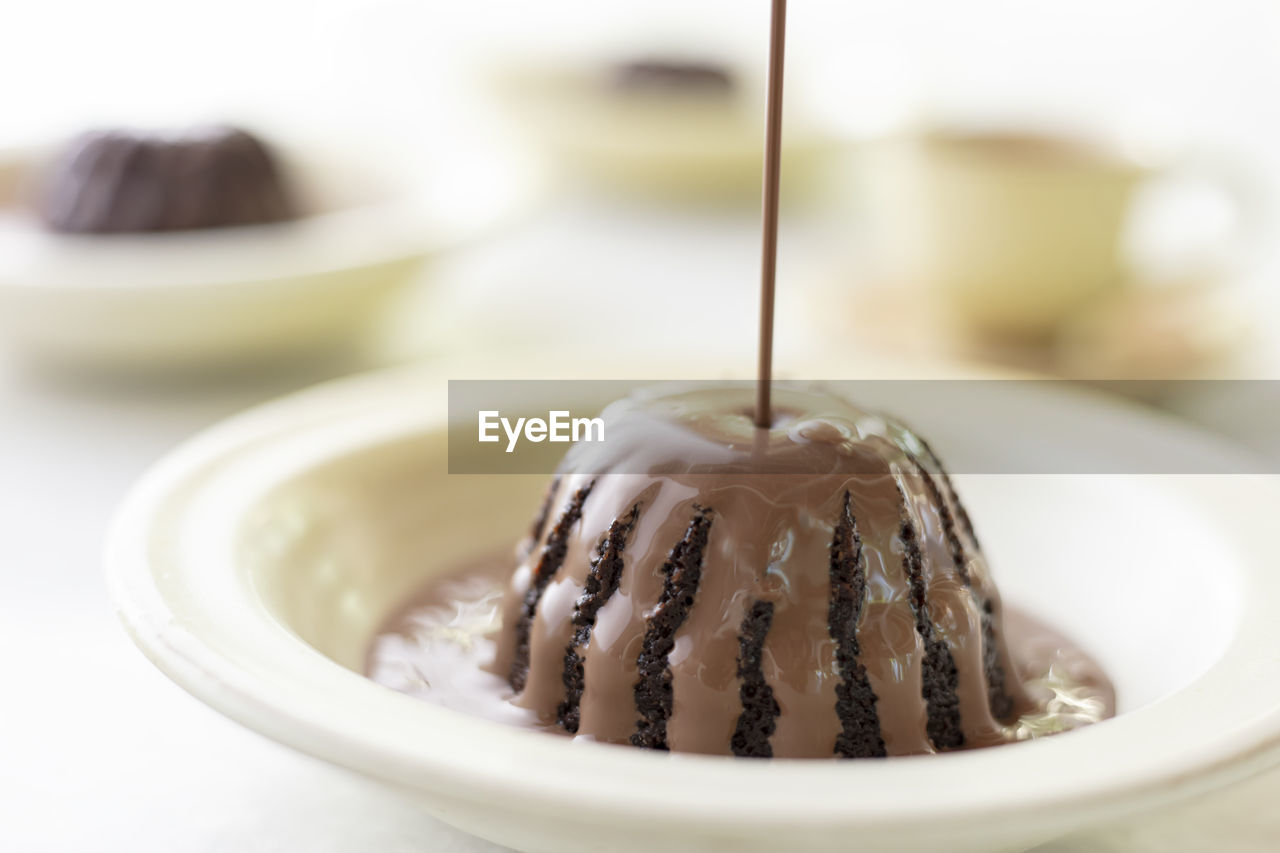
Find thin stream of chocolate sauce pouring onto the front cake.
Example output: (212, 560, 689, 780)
(755, 0, 787, 429)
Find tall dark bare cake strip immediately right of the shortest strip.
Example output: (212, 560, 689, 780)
(827, 492, 884, 758)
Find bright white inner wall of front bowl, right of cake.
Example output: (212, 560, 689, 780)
(954, 475, 1242, 713)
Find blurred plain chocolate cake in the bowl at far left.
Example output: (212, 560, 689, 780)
(41, 127, 297, 234)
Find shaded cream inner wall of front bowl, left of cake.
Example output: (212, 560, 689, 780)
(236, 432, 547, 672)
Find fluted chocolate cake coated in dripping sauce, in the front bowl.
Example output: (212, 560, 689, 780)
(495, 388, 1027, 758)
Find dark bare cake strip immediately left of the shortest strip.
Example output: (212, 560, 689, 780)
(631, 507, 712, 749)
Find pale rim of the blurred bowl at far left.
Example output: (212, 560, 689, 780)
(0, 133, 540, 289)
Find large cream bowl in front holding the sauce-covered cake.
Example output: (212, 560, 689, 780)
(108, 361, 1280, 850)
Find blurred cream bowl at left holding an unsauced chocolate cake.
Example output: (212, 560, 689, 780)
(0, 145, 531, 371)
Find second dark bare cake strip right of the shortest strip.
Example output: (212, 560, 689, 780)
(899, 487, 964, 749)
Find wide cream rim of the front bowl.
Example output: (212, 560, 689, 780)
(106, 368, 1280, 831)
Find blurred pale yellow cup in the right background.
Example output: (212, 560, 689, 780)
(877, 132, 1249, 339)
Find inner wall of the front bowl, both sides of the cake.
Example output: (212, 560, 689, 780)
(237, 422, 1239, 712)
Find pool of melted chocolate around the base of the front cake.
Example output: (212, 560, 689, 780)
(365, 551, 1115, 745)
